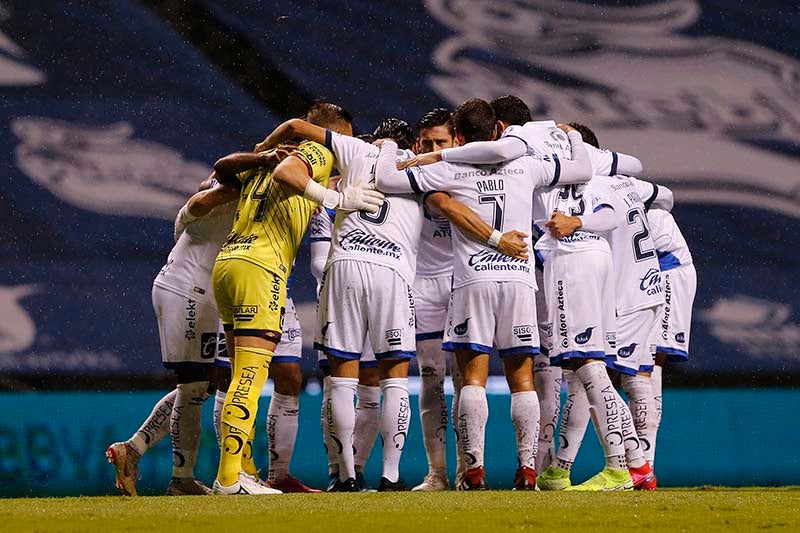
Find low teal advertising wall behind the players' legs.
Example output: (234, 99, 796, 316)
(0, 388, 800, 497)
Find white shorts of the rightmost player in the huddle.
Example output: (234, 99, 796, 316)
(655, 264, 697, 362)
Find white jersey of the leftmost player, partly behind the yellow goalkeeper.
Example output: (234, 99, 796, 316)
(153, 201, 237, 305)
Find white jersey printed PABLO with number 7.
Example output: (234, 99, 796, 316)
(407, 156, 558, 289)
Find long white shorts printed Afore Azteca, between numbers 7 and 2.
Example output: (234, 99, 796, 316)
(544, 250, 617, 365)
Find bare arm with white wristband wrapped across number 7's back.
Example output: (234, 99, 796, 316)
(425, 192, 528, 259)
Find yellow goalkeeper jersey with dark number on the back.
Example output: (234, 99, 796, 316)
(217, 141, 334, 281)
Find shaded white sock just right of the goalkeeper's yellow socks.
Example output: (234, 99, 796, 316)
(267, 392, 300, 482)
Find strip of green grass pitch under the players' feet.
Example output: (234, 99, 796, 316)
(0, 489, 800, 533)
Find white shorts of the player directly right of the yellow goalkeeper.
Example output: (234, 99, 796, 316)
(314, 261, 416, 360)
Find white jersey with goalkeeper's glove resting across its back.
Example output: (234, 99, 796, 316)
(326, 132, 423, 285)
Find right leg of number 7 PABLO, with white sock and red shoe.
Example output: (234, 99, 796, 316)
(503, 355, 541, 490)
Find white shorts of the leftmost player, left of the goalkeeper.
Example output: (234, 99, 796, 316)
(153, 285, 219, 369)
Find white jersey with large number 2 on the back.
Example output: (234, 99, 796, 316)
(587, 176, 664, 315)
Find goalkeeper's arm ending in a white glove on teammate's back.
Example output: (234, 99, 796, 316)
(272, 153, 383, 213)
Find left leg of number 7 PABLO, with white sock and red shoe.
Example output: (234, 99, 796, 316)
(456, 350, 489, 490)
